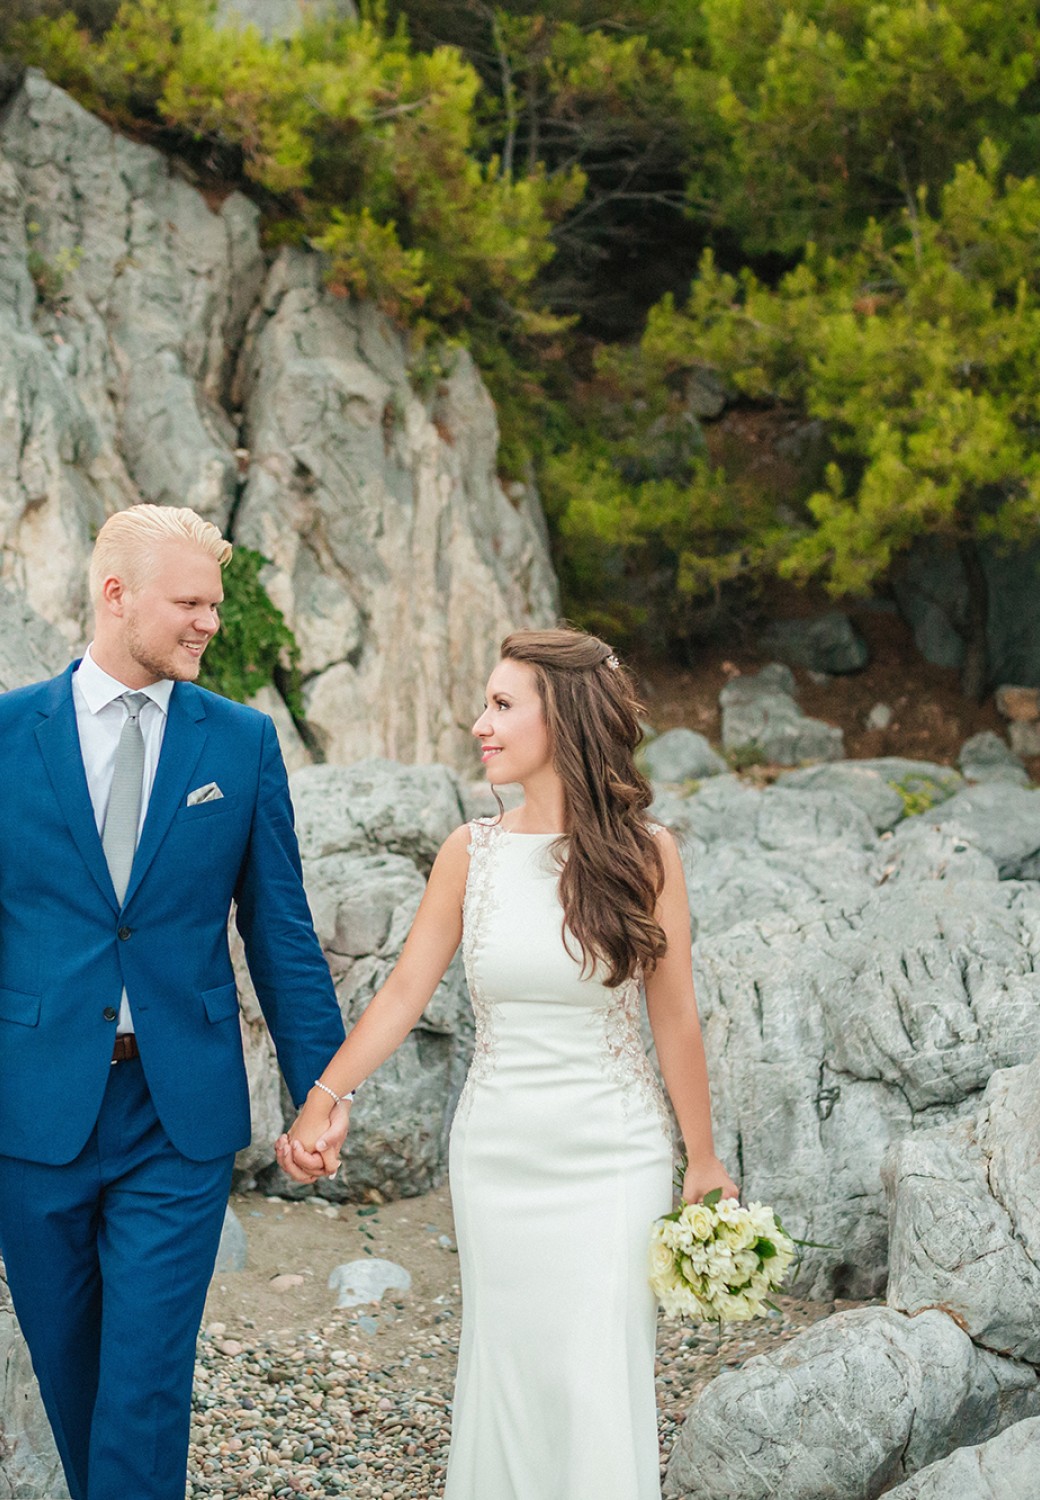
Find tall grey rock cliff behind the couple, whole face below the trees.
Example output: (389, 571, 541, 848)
(0, 71, 558, 767)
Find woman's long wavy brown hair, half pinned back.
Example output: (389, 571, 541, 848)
(501, 629, 666, 987)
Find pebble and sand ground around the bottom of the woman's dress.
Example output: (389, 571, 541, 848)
(188, 1194, 846, 1500)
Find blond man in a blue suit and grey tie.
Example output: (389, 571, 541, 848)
(0, 506, 344, 1500)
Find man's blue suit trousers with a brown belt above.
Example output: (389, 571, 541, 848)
(0, 1059, 234, 1500)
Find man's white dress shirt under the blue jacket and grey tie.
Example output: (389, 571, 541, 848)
(72, 647, 173, 1032)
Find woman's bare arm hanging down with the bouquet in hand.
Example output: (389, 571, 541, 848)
(647, 830, 738, 1203)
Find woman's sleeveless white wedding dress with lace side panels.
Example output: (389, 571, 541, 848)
(444, 821, 672, 1500)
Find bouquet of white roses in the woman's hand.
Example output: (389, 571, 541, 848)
(650, 1190, 795, 1323)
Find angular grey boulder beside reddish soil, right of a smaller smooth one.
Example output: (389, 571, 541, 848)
(719, 663, 845, 765)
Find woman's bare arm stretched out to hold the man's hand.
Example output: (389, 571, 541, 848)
(276, 824, 470, 1181)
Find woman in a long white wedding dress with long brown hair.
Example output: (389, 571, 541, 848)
(278, 630, 737, 1500)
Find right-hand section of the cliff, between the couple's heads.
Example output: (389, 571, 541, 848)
(236, 252, 557, 765)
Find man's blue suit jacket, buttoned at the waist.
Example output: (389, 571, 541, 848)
(0, 663, 344, 1166)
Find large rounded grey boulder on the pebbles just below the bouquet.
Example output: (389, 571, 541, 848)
(665, 1308, 1040, 1500)
